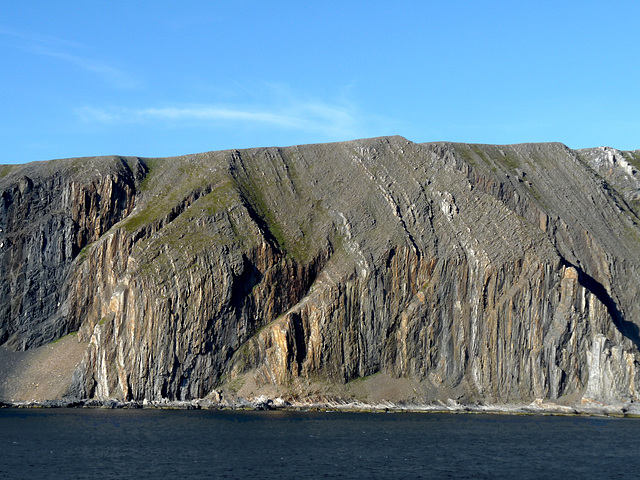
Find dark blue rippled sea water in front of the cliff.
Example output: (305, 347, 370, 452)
(0, 409, 640, 479)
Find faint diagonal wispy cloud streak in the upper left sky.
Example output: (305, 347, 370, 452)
(0, 25, 140, 90)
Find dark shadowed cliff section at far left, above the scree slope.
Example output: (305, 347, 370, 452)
(0, 157, 144, 349)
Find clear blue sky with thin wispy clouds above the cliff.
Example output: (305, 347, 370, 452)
(0, 0, 640, 163)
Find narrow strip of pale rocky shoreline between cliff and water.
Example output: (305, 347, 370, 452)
(0, 396, 640, 418)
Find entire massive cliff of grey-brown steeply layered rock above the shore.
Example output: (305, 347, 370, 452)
(0, 137, 640, 404)
